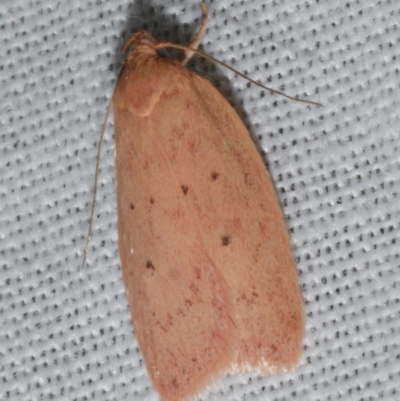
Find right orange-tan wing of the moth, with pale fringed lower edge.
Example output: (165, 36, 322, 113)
(152, 66, 303, 373)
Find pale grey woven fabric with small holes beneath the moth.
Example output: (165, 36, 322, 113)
(0, 0, 400, 401)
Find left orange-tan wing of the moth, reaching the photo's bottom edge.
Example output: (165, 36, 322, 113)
(114, 60, 237, 401)
